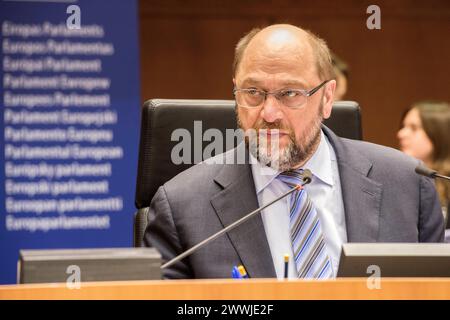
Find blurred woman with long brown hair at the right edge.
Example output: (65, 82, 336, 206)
(397, 101, 450, 228)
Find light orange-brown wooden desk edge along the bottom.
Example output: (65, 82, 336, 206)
(0, 278, 450, 300)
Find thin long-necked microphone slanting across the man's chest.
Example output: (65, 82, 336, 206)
(161, 169, 312, 269)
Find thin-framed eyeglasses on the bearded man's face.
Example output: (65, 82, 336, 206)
(233, 80, 330, 109)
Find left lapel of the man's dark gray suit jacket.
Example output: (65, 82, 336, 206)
(211, 148, 276, 278)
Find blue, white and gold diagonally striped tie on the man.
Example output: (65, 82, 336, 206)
(278, 169, 333, 279)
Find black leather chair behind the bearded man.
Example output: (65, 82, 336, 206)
(134, 99, 362, 247)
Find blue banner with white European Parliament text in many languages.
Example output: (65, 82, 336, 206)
(0, 0, 140, 283)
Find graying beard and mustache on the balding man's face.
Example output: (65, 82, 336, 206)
(237, 108, 323, 172)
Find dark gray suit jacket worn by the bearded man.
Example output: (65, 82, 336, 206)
(144, 127, 444, 278)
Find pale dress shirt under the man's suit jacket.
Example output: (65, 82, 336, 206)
(250, 132, 347, 279)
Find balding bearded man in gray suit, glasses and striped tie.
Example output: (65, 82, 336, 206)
(144, 25, 444, 278)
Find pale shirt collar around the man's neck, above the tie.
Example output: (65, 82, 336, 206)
(250, 131, 336, 194)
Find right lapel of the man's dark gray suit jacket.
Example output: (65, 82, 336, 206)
(323, 126, 382, 242)
